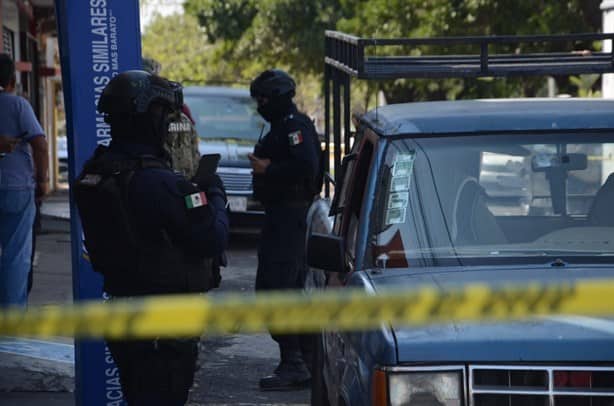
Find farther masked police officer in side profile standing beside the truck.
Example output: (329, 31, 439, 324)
(249, 69, 320, 390)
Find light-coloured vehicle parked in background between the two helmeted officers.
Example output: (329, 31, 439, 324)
(184, 86, 268, 231)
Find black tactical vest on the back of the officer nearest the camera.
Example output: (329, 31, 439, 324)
(73, 147, 214, 296)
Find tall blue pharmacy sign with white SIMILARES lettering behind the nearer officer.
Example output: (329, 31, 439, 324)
(55, 0, 141, 406)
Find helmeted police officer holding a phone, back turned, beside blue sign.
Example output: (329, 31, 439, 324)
(74, 71, 228, 406)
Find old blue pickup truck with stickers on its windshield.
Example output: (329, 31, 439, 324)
(308, 33, 614, 406)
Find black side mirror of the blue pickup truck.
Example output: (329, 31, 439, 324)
(307, 233, 345, 272)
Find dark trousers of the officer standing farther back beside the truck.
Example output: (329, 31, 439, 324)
(256, 201, 313, 368)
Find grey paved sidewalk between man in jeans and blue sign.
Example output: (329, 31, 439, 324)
(0, 190, 75, 406)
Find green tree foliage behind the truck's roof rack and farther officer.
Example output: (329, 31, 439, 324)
(144, 0, 601, 114)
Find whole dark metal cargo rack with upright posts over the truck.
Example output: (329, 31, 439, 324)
(324, 31, 614, 196)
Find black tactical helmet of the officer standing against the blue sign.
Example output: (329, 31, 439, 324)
(98, 70, 183, 115)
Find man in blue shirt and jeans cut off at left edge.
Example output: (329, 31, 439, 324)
(0, 54, 49, 306)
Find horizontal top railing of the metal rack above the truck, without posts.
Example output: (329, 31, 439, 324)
(325, 31, 614, 79)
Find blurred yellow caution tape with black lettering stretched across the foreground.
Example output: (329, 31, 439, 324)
(0, 280, 614, 338)
